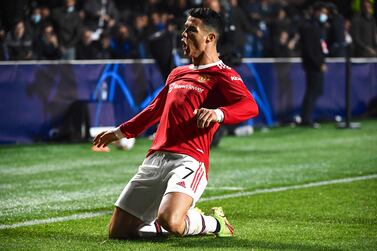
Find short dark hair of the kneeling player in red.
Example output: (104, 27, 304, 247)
(188, 8, 224, 40)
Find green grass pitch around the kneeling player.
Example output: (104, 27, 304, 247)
(0, 121, 377, 250)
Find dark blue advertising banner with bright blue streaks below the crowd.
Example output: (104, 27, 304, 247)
(0, 59, 377, 143)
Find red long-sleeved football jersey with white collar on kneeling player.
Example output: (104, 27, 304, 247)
(120, 61, 258, 174)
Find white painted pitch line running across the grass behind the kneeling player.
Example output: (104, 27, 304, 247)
(0, 174, 377, 230)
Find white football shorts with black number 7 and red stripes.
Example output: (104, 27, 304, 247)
(115, 152, 207, 223)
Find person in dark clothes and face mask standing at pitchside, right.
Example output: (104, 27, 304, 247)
(300, 2, 328, 128)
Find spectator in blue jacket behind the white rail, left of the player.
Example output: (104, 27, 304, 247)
(110, 24, 137, 59)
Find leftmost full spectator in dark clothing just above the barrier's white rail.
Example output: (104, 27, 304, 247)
(5, 20, 33, 60)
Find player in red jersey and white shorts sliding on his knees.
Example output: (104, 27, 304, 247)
(93, 8, 258, 239)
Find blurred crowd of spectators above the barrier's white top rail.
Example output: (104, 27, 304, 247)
(0, 0, 377, 61)
